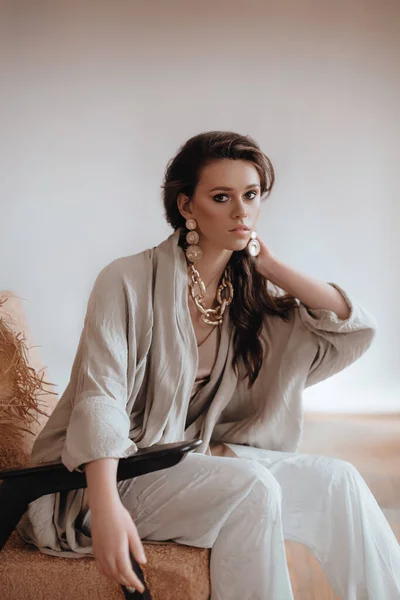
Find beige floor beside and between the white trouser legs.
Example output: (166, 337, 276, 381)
(286, 413, 400, 600)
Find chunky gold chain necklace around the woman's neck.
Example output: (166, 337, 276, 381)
(189, 264, 233, 325)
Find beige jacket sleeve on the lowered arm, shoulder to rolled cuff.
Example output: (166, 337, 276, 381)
(61, 259, 137, 471)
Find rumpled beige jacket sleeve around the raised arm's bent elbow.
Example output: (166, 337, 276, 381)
(299, 283, 376, 387)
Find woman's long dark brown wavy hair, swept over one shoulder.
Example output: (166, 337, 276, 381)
(162, 131, 297, 387)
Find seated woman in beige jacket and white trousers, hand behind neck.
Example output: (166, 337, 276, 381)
(19, 132, 400, 600)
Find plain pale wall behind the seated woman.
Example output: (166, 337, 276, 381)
(0, 0, 400, 411)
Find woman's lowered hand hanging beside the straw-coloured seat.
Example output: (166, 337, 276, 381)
(91, 498, 147, 593)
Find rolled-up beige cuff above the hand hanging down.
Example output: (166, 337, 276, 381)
(61, 397, 138, 472)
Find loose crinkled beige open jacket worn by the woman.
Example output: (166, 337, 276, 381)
(18, 231, 375, 557)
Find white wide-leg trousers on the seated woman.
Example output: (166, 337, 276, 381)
(98, 444, 400, 600)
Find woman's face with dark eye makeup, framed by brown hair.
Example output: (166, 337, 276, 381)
(178, 158, 261, 251)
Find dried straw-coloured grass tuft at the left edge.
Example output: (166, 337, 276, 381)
(0, 297, 57, 452)
